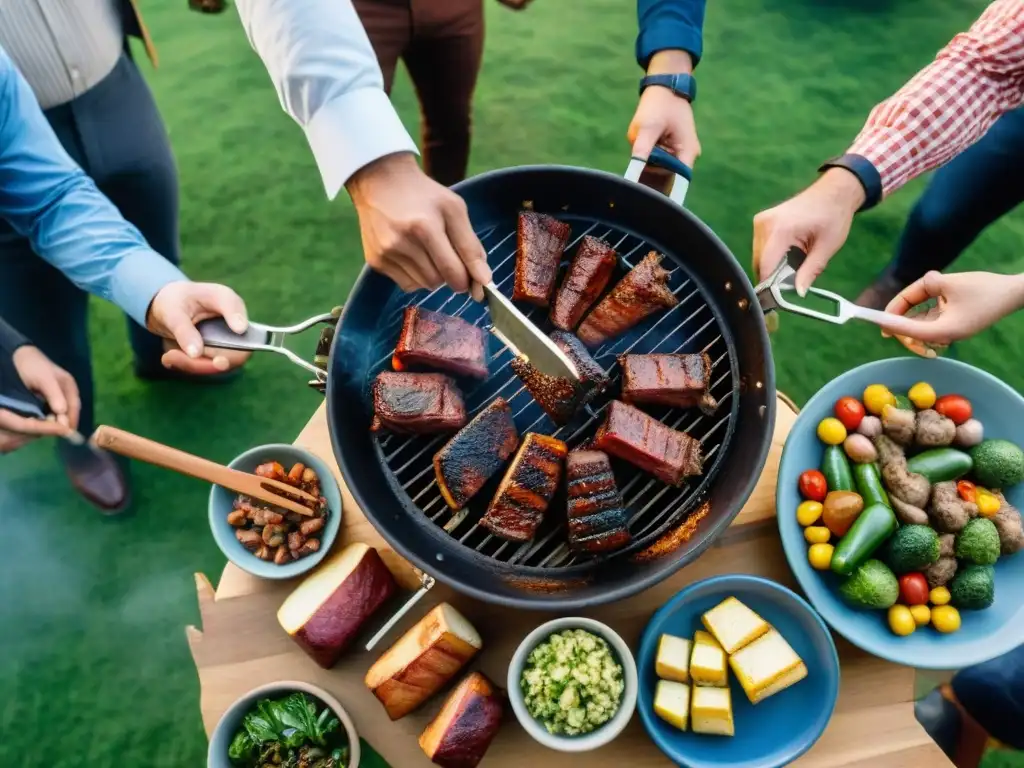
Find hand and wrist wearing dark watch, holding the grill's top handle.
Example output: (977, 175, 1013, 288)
(626, 50, 700, 166)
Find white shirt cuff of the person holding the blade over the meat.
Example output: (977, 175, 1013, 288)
(305, 88, 419, 200)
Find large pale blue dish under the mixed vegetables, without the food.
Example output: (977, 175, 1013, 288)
(775, 357, 1024, 670)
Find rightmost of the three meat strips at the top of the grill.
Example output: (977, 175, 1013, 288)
(577, 251, 679, 347)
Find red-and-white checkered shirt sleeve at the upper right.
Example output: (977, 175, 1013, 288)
(848, 0, 1024, 195)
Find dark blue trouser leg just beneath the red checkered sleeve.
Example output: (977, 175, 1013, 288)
(892, 108, 1024, 284)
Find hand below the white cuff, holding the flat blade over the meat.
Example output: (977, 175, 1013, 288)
(347, 153, 490, 301)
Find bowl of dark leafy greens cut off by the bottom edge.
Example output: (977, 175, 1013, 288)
(206, 680, 359, 768)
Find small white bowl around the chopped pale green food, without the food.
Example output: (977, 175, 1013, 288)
(508, 616, 639, 752)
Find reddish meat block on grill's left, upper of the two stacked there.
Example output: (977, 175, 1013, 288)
(391, 306, 487, 379)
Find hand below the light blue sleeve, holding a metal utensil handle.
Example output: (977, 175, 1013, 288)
(146, 281, 250, 376)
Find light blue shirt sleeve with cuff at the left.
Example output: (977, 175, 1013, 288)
(0, 48, 187, 327)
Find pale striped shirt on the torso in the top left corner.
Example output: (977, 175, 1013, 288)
(0, 0, 124, 110)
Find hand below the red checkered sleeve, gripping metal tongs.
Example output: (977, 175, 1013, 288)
(754, 168, 864, 296)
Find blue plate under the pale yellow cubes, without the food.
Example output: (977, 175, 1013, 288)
(637, 574, 839, 768)
